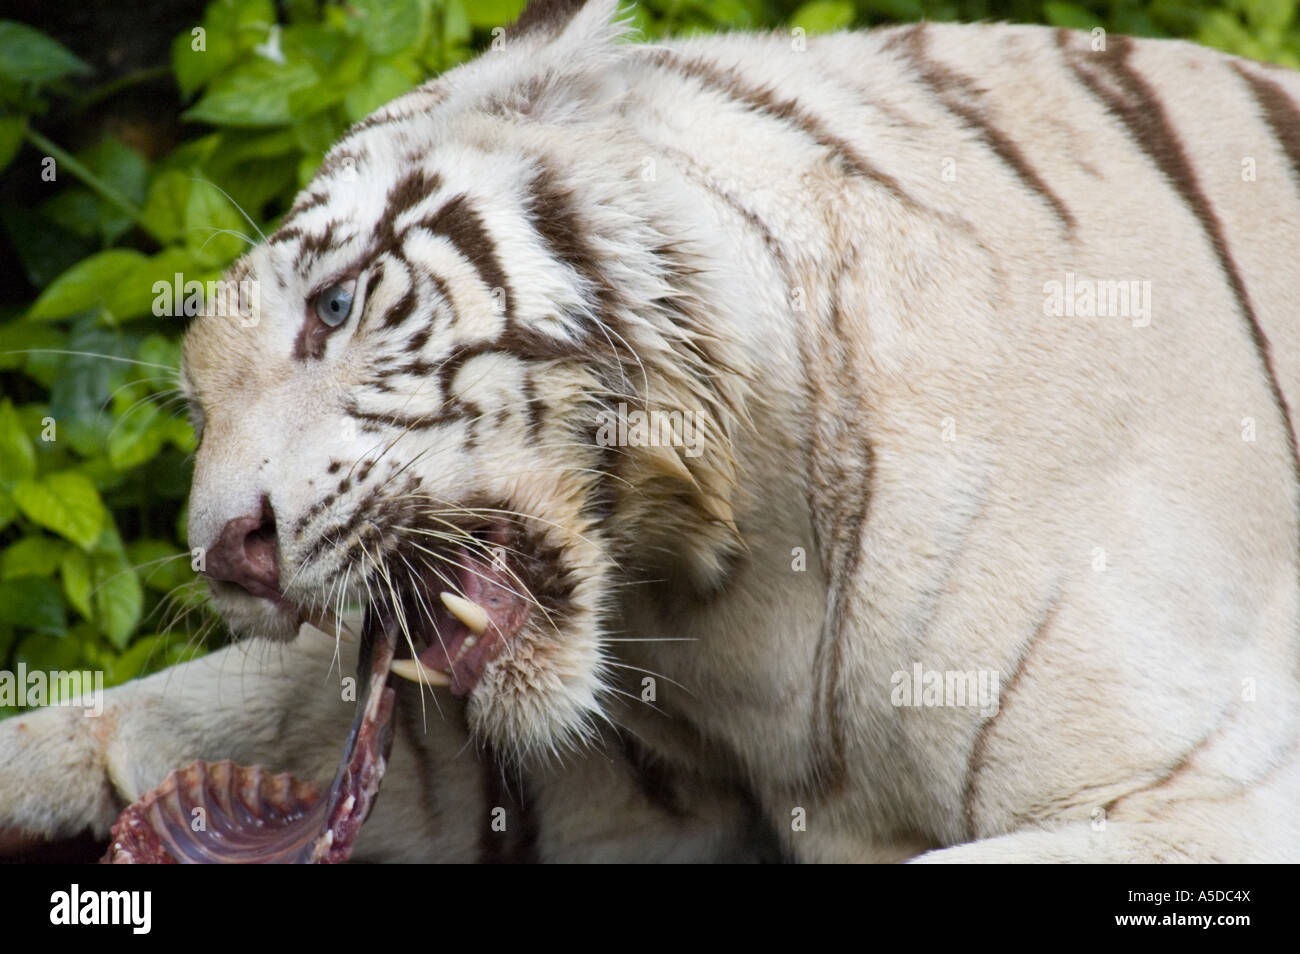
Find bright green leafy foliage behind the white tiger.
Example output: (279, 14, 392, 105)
(0, 0, 1300, 715)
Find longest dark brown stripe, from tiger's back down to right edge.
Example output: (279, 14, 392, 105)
(1057, 30, 1300, 493)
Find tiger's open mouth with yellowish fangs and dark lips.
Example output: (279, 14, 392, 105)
(376, 522, 534, 697)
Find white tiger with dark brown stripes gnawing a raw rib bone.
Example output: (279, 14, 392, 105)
(0, 0, 1300, 862)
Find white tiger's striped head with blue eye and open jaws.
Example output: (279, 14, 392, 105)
(182, 0, 746, 755)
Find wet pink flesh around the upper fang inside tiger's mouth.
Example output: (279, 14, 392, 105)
(418, 554, 529, 695)
